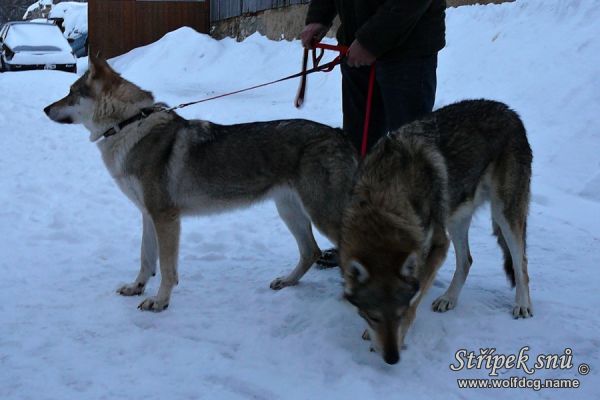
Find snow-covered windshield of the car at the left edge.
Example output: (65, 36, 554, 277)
(4, 23, 71, 52)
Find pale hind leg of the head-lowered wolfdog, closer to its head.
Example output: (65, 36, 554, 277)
(432, 211, 473, 312)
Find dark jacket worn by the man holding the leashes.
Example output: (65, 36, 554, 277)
(306, 0, 446, 59)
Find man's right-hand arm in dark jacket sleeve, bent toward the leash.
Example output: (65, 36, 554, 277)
(354, 0, 432, 57)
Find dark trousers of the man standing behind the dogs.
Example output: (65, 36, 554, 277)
(341, 54, 437, 151)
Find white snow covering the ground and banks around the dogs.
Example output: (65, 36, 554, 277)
(0, 0, 600, 400)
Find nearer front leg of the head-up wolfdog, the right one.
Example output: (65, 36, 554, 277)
(138, 210, 181, 312)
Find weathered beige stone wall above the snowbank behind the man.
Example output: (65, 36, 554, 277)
(211, 0, 514, 40)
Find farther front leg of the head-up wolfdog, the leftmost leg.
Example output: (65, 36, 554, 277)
(117, 214, 158, 296)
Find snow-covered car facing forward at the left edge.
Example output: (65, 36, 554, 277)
(0, 21, 77, 72)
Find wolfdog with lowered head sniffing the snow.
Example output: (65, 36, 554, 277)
(340, 100, 533, 364)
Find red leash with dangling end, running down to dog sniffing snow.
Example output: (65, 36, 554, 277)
(294, 43, 375, 158)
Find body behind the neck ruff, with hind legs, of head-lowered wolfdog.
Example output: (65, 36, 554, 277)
(404, 100, 533, 318)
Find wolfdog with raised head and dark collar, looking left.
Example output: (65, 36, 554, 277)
(44, 57, 357, 311)
